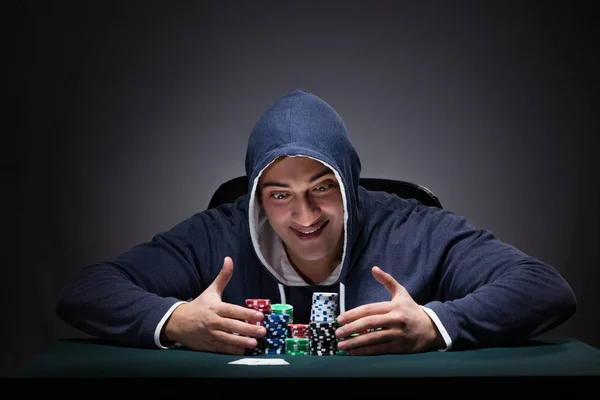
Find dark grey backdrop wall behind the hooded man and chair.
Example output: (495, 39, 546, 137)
(1, 0, 600, 376)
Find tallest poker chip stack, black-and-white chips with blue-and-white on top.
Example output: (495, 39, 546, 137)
(309, 292, 338, 356)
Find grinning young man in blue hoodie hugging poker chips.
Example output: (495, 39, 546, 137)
(57, 90, 576, 355)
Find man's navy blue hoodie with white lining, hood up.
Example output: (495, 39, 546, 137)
(56, 89, 576, 349)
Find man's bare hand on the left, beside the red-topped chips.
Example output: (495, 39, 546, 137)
(163, 257, 266, 355)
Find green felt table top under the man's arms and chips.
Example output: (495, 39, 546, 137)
(3, 338, 600, 390)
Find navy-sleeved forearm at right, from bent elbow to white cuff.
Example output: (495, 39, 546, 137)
(426, 263, 576, 349)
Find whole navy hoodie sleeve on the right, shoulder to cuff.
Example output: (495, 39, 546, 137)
(425, 211, 577, 350)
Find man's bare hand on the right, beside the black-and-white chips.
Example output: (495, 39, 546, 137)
(336, 267, 445, 355)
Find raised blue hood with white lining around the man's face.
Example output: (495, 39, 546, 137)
(245, 89, 361, 286)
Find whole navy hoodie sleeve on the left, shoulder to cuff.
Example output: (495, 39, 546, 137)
(56, 209, 227, 347)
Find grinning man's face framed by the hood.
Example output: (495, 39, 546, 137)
(259, 157, 344, 262)
